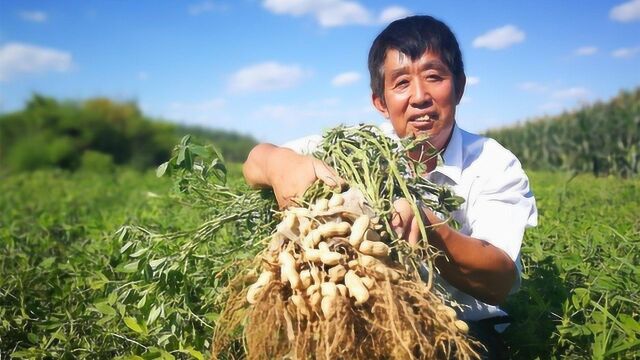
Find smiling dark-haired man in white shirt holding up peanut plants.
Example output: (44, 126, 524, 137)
(244, 16, 537, 357)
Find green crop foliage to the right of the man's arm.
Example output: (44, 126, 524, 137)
(507, 172, 640, 359)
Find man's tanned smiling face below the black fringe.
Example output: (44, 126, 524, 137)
(373, 49, 464, 150)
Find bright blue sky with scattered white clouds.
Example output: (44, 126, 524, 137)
(0, 0, 640, 144)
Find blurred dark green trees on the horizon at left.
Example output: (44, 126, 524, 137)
(0, 95, 256, 172)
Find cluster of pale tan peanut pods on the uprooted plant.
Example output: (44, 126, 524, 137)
(247, 190, 400, 319)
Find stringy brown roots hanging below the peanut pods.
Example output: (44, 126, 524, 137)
(213, 280, 479, 360)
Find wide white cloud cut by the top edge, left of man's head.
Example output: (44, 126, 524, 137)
(262, 0, 373, 27)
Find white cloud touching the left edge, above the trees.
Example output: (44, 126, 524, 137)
(0, 43, 73, 81)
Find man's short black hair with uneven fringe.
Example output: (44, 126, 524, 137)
(369, 15, 464, 100)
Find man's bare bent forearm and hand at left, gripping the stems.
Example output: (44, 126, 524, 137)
(242, 144, 343, 208)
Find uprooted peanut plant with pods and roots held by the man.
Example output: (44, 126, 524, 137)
(191, 126, 477, 359)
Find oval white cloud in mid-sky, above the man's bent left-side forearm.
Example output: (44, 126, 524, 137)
(228, 62, 306, 93)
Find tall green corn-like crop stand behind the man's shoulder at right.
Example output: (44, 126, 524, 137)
(486, 88, 640, 177)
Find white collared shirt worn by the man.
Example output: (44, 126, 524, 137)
(283, 122, 538, 320)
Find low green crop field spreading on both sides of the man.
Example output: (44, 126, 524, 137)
(0, 167, 640, 359)
